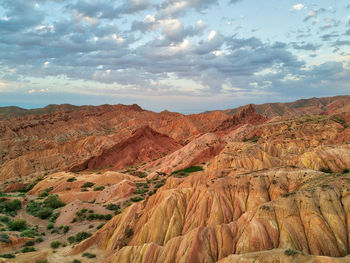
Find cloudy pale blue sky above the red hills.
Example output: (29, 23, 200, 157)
(0, 0, 350, 113)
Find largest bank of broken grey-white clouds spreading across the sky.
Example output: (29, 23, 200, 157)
(0, 0, 350, 110)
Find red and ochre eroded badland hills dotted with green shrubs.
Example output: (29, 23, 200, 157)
(0, 97, 350, 263)
